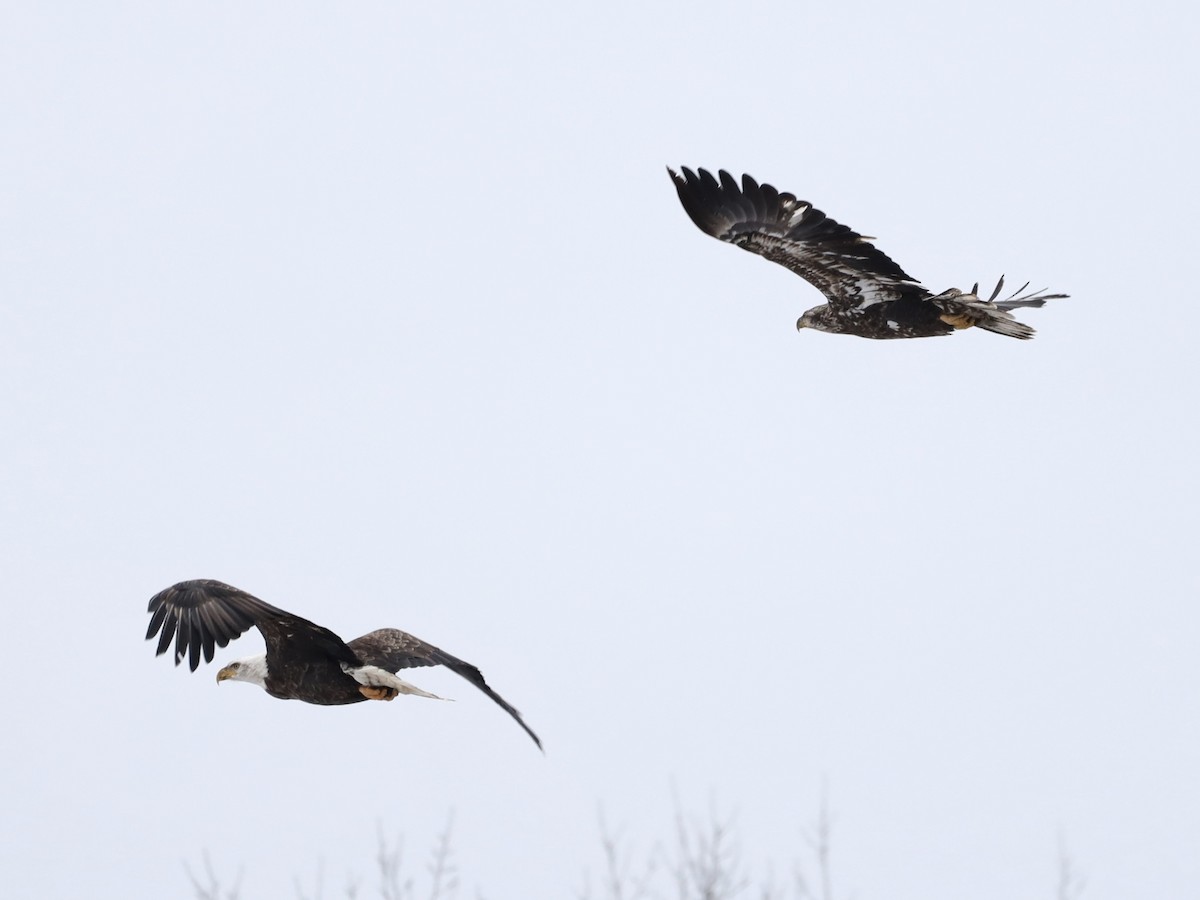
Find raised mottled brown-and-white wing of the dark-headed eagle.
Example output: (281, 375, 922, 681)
(667, 168, 929, 312)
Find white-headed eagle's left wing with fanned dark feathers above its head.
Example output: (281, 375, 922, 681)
(146, 578, 358, 672)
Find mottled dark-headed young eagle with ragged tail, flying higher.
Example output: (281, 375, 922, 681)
(667, 168, 1067, 341)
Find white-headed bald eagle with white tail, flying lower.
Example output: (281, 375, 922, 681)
(146, 578, 541, 748)
